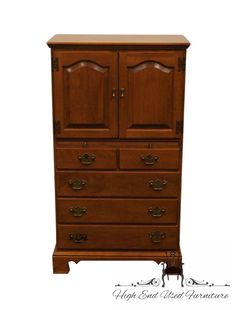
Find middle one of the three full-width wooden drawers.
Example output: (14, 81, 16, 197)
(57, 198, 179, 224)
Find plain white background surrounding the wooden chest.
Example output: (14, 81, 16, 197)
(0, 0, 236, 310)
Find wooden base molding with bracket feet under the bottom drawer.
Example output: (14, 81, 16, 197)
(53, 248, 182, 275)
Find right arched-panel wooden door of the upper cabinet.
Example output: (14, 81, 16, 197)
(119, 51, 184, 138)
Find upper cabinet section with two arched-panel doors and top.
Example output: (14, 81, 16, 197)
(48, 35, 189, 139)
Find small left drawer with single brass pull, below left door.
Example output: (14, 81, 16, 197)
(56, 148, 117, 170)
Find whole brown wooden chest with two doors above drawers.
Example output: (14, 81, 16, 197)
(48, 35, 189, 273)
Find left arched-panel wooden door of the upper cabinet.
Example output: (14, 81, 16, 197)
(53, 51, 118, 138)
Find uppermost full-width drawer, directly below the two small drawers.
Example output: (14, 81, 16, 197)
(56, 171, 179, 198)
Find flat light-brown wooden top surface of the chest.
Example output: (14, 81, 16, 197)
(47, 34, 190, 48)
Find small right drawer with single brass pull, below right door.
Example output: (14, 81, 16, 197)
(120, 148, 179, 170)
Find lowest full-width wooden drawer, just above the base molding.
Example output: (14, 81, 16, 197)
(57, 224, 178, 250)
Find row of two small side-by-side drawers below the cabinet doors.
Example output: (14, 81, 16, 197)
(55, 143, 180, 170)
